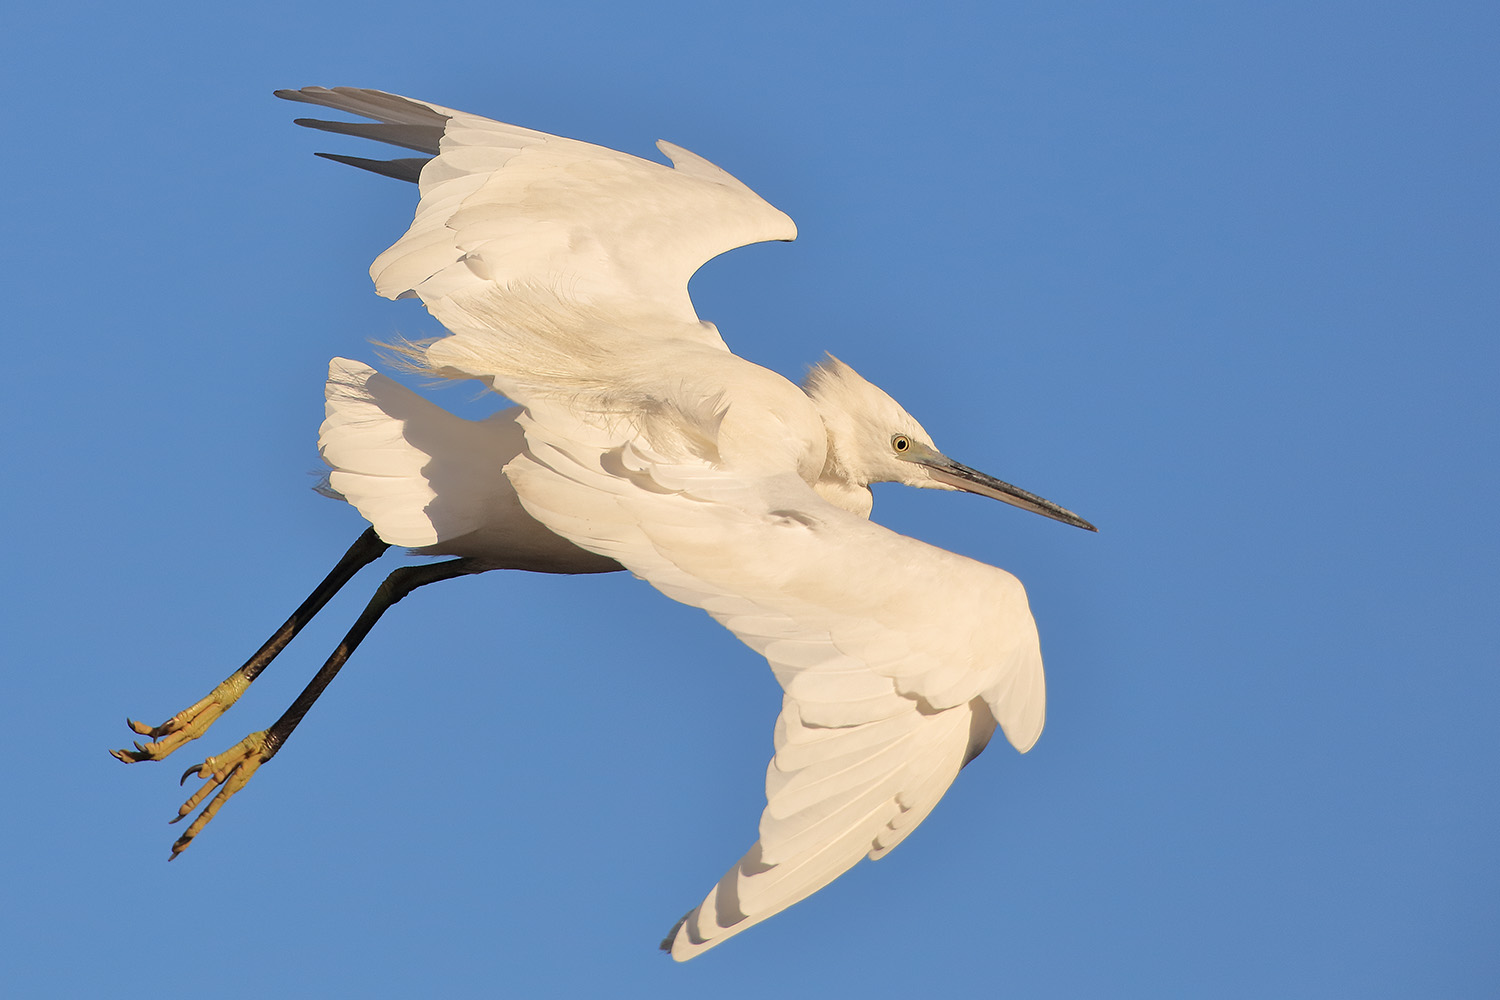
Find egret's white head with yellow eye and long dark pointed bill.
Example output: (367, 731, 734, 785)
(804, 354, 1095, 531)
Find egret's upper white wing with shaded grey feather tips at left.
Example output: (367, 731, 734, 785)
(276, 87, 797, 332)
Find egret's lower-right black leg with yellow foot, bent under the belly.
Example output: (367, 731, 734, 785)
(173, 559, 483, 858)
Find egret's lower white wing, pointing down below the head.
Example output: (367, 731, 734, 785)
(506, 402, 1046, 960)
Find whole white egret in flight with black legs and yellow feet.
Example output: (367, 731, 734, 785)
(113, 87, 1094, 960)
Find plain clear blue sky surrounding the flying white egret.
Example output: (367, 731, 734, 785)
(0, 0, 1500, 997)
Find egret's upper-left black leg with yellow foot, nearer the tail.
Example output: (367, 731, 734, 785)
(110, 528, 390, 763)
